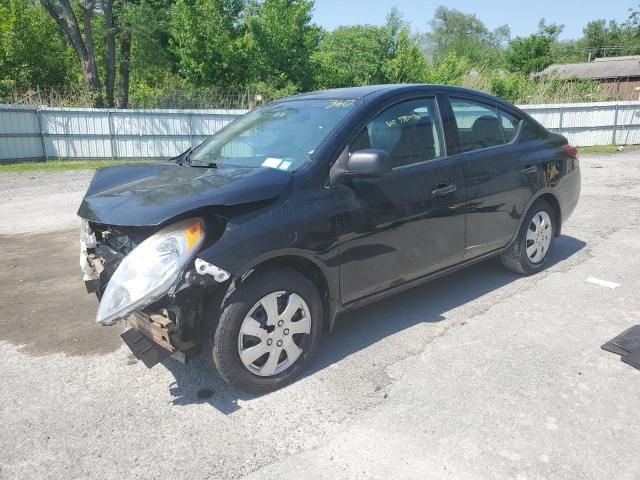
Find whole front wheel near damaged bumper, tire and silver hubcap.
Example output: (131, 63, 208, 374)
(207, 269, 323, 393)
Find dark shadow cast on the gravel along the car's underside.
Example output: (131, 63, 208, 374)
(164, 235, 586, 414)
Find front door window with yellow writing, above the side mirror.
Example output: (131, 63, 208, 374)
(349, 98, 445, 168)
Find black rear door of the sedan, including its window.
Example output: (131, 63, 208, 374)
(449, 96, 540, 259)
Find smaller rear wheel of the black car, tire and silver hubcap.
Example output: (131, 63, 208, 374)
(501, 200, 556, 275)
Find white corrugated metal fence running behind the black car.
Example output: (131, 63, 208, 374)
(0, 102, 640, 162)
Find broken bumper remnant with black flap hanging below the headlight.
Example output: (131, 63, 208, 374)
(120, 313, 176, 368)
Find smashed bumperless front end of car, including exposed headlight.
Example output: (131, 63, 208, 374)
(80, 218, 230, 367)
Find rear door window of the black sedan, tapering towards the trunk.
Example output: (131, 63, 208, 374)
(450, 98, 519, 152)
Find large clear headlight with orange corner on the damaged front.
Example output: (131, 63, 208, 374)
(96, 218, 204, 325)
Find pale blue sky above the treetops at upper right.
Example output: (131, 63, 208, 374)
(314, 0, 640, 40)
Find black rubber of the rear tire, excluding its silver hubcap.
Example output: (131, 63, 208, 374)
(500, 199, 558, 275)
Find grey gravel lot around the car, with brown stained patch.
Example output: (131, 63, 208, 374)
(0, 153, 640, 480)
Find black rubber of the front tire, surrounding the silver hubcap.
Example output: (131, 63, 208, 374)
(205, 269, 324, 394)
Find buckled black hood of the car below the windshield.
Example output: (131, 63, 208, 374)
(78, 163, 291, 226)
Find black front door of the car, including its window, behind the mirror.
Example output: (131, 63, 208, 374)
(332, 97, 465, 304)
